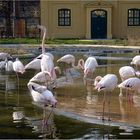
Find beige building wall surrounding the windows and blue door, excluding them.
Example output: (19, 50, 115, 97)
(41, 0, 140, 38)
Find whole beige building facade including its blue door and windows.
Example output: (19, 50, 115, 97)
(40, 0, 140, 39)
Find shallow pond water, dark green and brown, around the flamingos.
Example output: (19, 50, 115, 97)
(0, 50, 140, 139)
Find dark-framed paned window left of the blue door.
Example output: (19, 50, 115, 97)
(58, 9, 71, 26)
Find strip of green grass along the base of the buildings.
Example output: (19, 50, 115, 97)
(0, 38, 127, 45)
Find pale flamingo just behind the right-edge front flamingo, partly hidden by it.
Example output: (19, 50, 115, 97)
(119, 66, 140, 97)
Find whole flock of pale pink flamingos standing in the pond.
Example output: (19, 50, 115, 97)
(0, 25, 140, 119)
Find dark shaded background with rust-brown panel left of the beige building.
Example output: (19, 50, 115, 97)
(0, 0, 40, 38)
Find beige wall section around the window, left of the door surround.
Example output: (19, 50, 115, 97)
(41, 1, 86, 38)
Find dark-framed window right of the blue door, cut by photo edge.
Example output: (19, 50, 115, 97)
(128, 9, 140, 26)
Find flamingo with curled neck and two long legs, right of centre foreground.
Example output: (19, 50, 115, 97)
(94, 74, 118, 120)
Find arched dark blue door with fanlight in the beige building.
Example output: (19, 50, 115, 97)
(91, 9, 107, 39)
